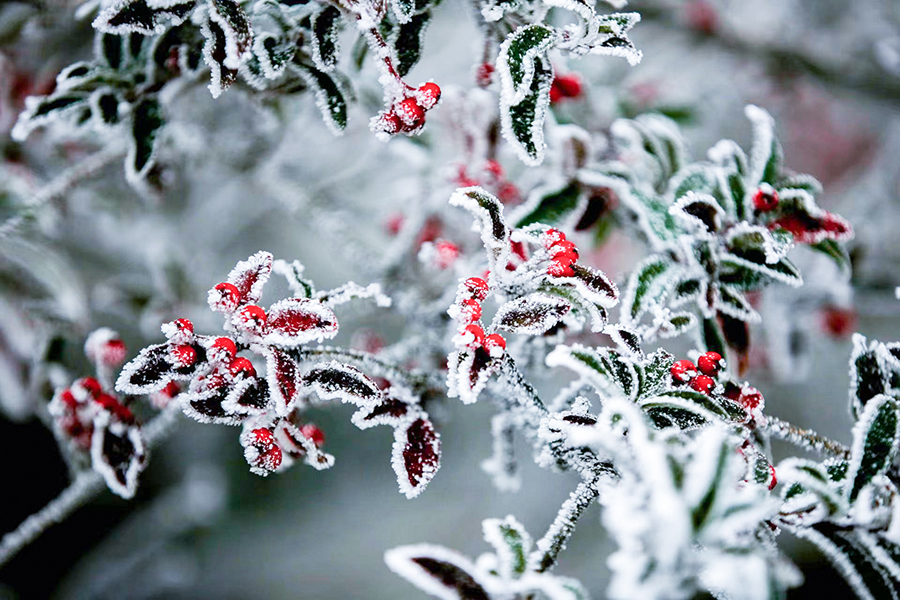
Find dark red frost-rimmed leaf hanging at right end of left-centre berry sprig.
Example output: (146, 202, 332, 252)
(391, 416, 441, 498)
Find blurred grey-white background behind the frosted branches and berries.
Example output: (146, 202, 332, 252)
(0, 0, 900, 599)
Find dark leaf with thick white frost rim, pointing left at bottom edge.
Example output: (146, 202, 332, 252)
(384, 544, 490, 600)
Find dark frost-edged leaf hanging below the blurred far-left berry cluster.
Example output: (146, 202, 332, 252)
(91, 410, 147, 499)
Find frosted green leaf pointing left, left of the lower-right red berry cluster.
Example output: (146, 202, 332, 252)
(547, 344, 639, 400)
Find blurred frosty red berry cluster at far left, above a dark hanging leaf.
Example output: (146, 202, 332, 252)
(48, 377, 134, 450)
